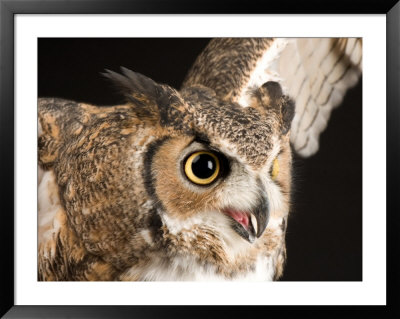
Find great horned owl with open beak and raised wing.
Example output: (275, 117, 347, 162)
(38, 38, 361, 280)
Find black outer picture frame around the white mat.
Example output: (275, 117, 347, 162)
(0, 0, 400, 318)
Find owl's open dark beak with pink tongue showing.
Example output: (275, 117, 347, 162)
(223, 196, 269, 243)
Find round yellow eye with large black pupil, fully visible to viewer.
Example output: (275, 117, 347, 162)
(184, 151, 220, 185)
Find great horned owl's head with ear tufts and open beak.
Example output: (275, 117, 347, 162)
(105, 68, 294, 248)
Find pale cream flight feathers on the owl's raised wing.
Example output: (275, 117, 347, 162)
(278, 38, 362, 157)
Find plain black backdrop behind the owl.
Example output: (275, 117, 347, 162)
(38, 38, 362, 281)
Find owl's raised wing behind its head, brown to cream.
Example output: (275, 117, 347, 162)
(184, 38, 362, 157)
